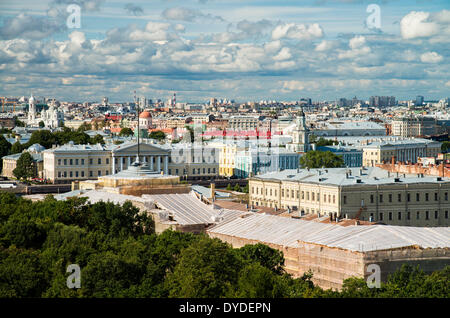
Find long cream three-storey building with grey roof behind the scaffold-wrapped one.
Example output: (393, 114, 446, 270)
(249, 167, 450, 226)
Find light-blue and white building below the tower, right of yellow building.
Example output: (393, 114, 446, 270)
(234, 148, 300, 178)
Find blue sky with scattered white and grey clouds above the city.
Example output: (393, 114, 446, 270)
(0, 0, 450, 102)
